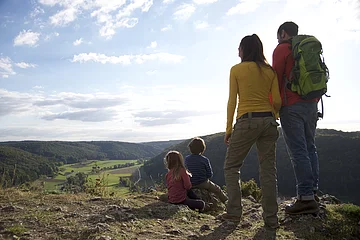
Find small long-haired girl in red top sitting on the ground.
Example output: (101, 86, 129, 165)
(164, 151, 205, 211)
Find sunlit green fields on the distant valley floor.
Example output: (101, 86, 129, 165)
(45, 160, 142, 192)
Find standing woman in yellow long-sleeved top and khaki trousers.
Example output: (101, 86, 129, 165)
(222, 34, 281, 229)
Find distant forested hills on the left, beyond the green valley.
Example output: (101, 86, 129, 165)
(0, 141, 180, 187)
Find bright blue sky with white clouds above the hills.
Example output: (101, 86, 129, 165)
(0, 0, 360, 142)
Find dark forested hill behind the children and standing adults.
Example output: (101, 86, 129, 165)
(144, 129, 360, 204)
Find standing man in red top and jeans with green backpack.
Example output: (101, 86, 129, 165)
(272, 22, 328, 214)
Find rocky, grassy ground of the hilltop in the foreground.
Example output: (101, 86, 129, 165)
(0, 189, 360, 240)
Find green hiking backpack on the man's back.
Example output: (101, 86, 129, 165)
(288, 35, 329, 100)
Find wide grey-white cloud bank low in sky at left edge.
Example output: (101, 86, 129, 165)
(0, 86, 128, 122)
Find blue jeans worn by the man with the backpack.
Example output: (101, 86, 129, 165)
(280, 102, 319, 200)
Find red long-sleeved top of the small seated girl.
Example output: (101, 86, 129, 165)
(166, 168, 192, 203)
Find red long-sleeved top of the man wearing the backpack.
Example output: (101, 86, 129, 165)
(272, 42, 318, 106)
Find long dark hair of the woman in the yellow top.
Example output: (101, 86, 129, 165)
(239, 34, 271, 67)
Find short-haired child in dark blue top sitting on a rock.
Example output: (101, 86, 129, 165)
(185, 137, 228, 203)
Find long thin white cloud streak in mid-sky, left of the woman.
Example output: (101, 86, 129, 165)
(72, 53, 184, 65)
